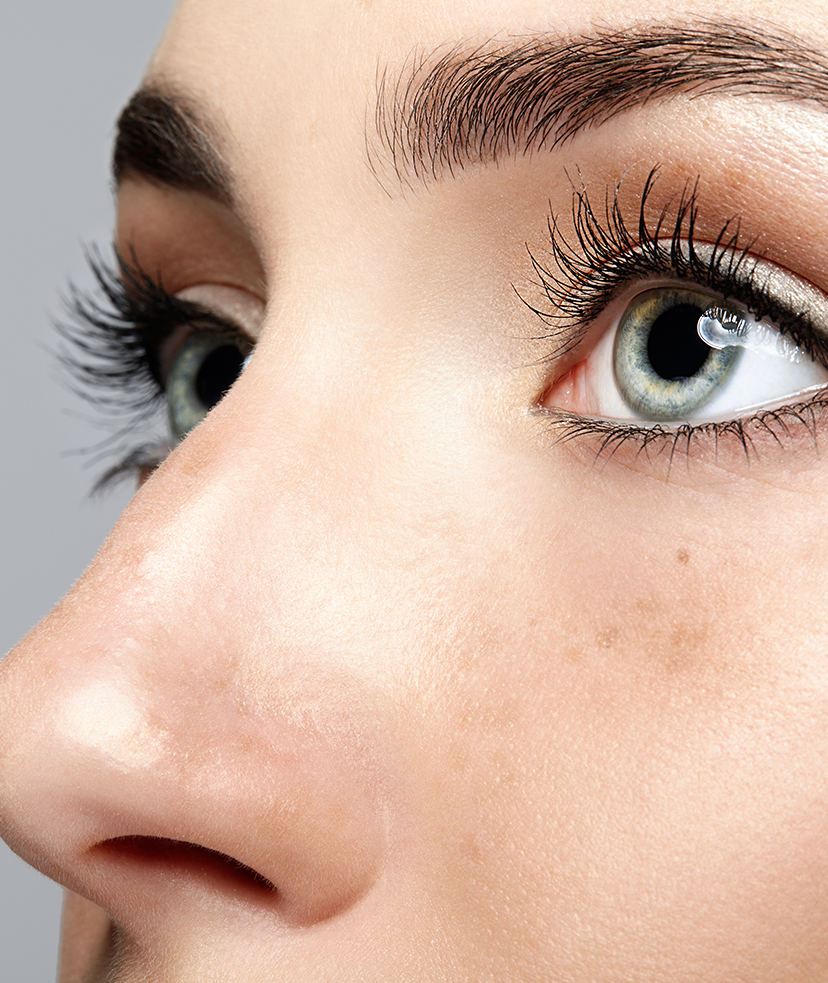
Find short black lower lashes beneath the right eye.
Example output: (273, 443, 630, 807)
(535, 387, 828, 474)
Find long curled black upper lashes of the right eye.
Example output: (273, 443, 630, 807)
(521, 166, 828, 366)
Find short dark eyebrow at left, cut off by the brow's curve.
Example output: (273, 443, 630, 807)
(112, 86, 232, 203)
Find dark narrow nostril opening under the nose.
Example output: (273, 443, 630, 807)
(93, 836, 279, 905)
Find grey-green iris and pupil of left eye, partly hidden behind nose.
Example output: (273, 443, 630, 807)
(166, 330, 250, 440)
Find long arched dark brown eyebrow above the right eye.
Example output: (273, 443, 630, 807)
(368, 22, 828, 182)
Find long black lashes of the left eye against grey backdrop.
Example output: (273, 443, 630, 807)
(56, 250, 228, 493)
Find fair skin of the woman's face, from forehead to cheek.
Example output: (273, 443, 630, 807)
(0, 0, 828, 983)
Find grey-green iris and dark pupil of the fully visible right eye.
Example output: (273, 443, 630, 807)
(613, 287, 742, 421)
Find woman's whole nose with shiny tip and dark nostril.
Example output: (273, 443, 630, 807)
(0, 406, 384, 938)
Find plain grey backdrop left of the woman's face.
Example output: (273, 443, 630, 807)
(0, 0, 173, 983)
